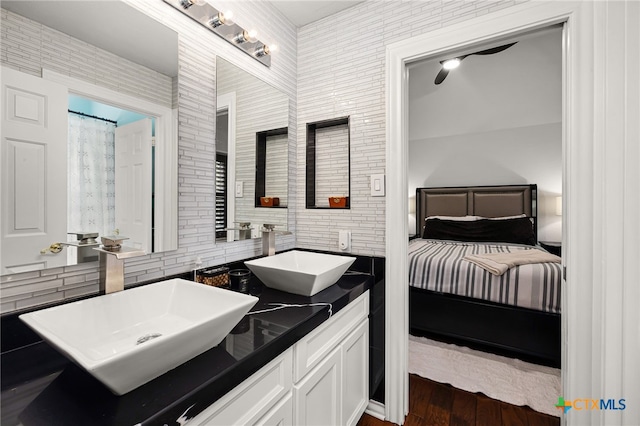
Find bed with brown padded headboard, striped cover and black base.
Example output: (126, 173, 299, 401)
(409, 185, 562, 367)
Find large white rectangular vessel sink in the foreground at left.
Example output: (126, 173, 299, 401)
(20, 279, 258, 395)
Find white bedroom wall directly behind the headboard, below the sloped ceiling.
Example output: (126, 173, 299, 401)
(408, 123, 562, 241)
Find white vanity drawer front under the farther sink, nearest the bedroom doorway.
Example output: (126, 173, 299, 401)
(293, 291, 369, 382)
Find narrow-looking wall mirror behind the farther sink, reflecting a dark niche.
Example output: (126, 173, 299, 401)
(216, 57, 289, 241)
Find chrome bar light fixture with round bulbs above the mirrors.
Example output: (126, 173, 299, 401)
(163, 0, 275, 67)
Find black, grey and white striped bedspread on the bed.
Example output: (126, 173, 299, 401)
(409, 239, 561, 313)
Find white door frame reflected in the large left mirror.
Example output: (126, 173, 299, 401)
(42, 69, 178, 253)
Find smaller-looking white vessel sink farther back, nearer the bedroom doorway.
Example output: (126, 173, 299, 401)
(244, 250, 356, 296)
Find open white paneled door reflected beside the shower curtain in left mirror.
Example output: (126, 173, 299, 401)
(115, 118, 153, 253)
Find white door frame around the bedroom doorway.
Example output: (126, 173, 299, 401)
(385, 2, 593, 424)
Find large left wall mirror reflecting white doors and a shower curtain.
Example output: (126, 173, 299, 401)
(0, 1, 178, 275)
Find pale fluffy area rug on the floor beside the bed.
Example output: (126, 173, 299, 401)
(409, 336, 561, 416)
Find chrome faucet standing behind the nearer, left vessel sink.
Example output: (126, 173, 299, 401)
(94, 235, 146, 294)
